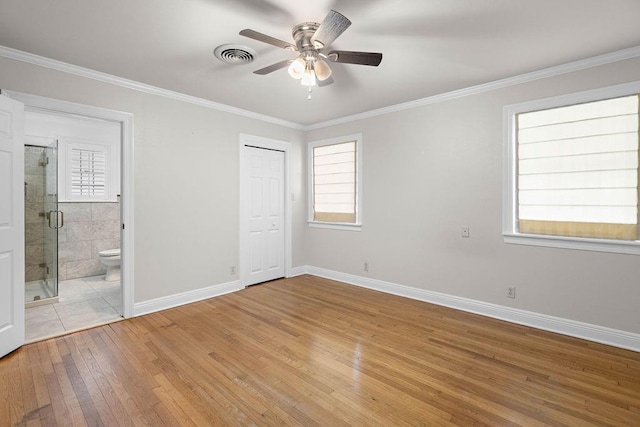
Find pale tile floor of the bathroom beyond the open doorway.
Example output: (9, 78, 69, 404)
(25, 275, 122, 342)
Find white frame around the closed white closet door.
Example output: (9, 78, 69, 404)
(238, 133, 292, 287)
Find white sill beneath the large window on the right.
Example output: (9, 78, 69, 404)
(503, 233, 640, 255)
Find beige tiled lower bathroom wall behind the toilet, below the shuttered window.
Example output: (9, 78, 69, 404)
(58, 202, 120, 280)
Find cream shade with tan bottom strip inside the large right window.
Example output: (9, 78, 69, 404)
(517, 95, 639, 240)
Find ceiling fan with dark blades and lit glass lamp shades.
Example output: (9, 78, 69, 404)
(240, 10, 382, 99)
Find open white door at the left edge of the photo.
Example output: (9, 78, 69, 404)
(0, 95, 24, 357)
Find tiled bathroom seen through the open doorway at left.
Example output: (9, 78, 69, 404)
(24, 110, 122, 341)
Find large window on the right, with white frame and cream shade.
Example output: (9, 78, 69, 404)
(504, 85, 640, 253)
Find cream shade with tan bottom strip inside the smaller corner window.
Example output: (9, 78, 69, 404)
(313, 141, 358, 223)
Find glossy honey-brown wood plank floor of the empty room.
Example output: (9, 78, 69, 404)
(0, 276, 640, 426)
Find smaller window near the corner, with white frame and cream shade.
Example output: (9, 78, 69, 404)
(309, 135, 362, 230)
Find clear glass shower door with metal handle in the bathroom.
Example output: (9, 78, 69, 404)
(43, 140, 58, 297)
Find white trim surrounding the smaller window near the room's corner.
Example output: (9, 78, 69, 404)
(307, 133, 364, 231)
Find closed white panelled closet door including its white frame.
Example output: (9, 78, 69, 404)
(239, 135, 291, 286)
